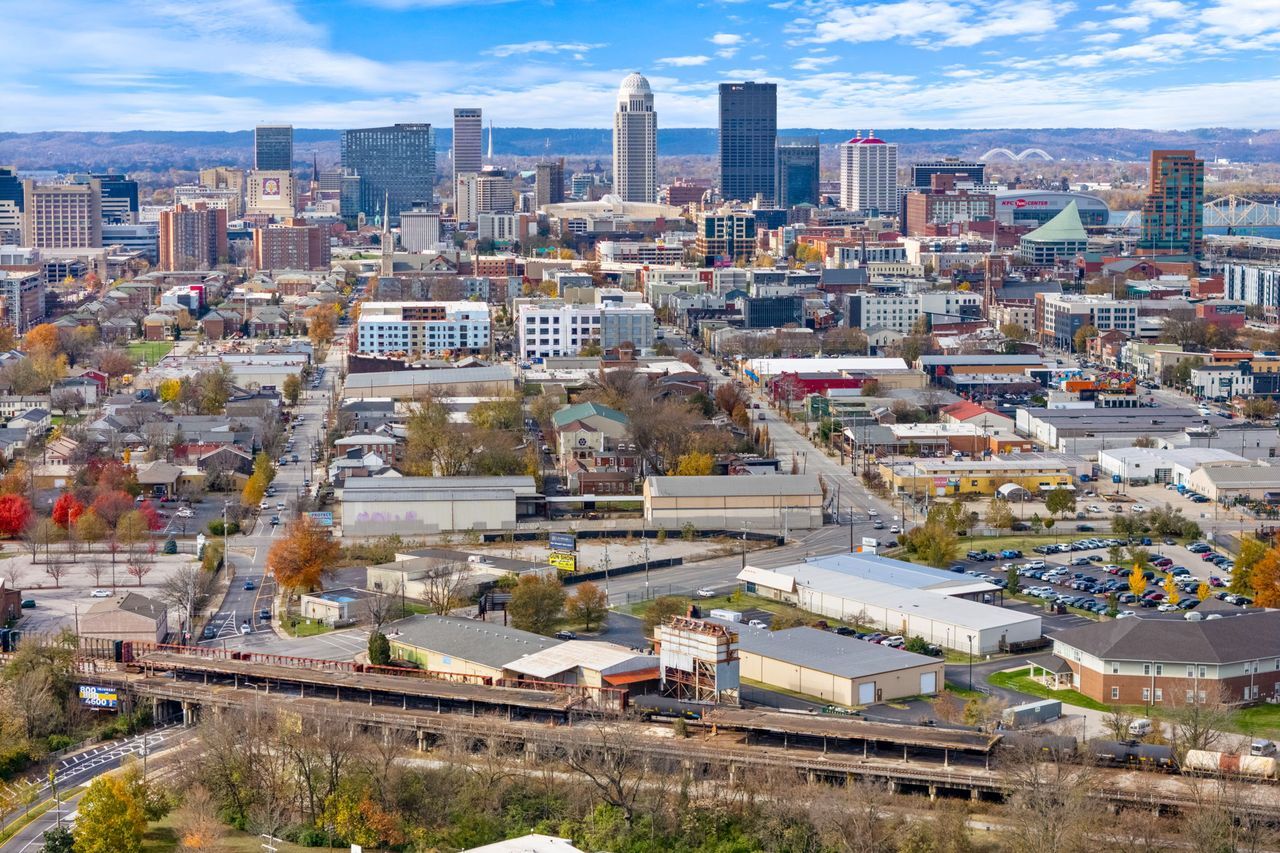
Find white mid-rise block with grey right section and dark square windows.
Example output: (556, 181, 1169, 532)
(516, 300, 654, 359)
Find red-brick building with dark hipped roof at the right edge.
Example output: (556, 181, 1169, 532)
(1053, 612, 1280, 704)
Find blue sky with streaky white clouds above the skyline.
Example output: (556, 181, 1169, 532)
(0, 0, 1280, 131)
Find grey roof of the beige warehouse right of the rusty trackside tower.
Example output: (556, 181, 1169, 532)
(708, 619, 942, 679)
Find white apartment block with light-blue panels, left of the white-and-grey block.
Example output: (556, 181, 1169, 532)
(356, 302, 490, 355)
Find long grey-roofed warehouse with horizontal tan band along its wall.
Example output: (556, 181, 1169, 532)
(644, 474, 822, 530)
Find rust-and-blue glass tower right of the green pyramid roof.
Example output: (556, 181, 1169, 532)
(1138, 150, 1204, 257)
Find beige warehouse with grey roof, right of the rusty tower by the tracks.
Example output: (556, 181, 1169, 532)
(713, 620, 946, 706)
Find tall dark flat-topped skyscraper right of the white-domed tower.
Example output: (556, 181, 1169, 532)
(719, 82, 778, 201)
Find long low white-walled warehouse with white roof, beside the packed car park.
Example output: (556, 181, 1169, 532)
(737, 562, 1041, 654)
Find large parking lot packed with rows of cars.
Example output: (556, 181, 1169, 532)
(952, 537, 1252, 617)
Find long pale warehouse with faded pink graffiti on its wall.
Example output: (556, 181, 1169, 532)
(342, 476, 539, 537)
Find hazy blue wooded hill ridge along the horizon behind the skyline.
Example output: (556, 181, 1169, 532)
(0, 127, 1280, 172)
